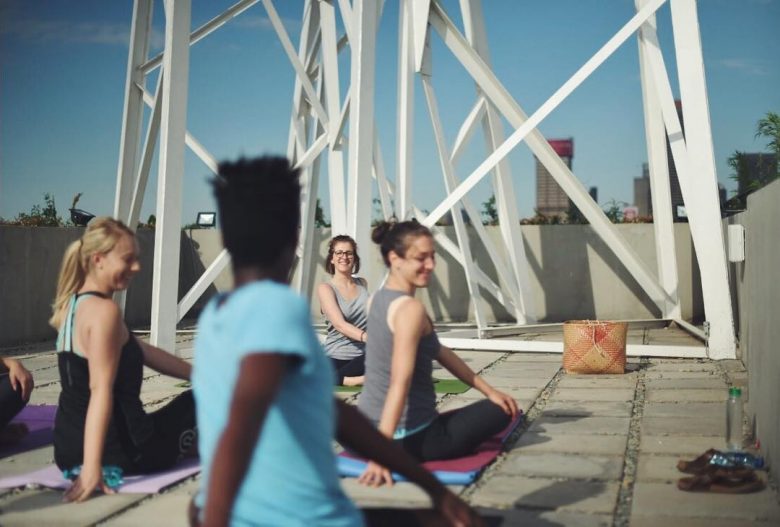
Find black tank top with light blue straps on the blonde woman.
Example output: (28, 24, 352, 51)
(54, 291, 154, 471)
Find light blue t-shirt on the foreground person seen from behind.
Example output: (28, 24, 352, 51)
(192, 280, 363, 527)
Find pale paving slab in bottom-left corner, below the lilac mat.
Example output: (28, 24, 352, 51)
(0, 490, 146, 527)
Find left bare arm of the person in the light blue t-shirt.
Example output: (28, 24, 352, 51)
(203, 353, 291, 527)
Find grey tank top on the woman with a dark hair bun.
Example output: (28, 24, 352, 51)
(358, 289, 441, 436)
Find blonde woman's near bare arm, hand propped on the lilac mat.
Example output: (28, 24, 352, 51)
(64, 301, 123, 502)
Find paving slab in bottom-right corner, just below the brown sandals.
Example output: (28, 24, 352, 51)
(632, 481, 780, 523)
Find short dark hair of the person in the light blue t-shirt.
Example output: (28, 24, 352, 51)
(212, 156, 301, 267)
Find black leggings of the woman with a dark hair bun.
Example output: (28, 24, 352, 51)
(396, 399, 512, 461)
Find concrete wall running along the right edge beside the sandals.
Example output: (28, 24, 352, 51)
(727, 180, 780, 470)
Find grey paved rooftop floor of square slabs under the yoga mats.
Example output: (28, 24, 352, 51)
(0, 335, 780, 527)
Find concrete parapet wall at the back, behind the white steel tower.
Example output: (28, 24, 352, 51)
(0, 224, 703, 346)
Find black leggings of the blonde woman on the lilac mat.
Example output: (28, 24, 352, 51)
(128, 390, 197, 474)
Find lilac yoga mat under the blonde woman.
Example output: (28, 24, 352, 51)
(0, 459, 200, 494)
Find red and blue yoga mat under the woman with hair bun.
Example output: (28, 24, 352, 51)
(337, 412, 523, 485)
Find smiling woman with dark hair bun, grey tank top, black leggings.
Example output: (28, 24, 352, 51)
(358, 221, 519, 486)
